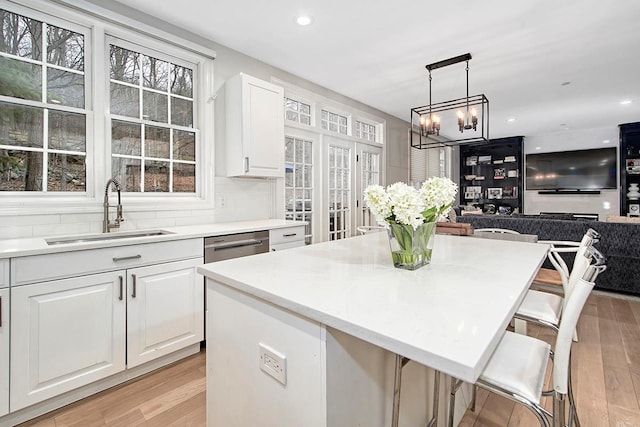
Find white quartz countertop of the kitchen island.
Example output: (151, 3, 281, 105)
(198, 233, 548, 382)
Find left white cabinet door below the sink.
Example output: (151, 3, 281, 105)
(10, 271, 126, 412)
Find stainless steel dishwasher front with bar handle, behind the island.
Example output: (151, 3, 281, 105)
(204, 230, 269, 263)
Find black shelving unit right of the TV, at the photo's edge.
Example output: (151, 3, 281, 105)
(619, 122, 640, 216)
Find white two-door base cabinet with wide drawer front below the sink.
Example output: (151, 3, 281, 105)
(10, 239, 204, 412)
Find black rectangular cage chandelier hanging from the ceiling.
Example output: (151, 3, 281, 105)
(410, 53, 489, 149)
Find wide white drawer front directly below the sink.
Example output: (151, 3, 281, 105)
(11, 238, 203, 286)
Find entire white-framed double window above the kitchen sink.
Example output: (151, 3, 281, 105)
(0, 1, 215, 207)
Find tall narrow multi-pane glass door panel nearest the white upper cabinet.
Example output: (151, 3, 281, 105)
(284, 136, 313, 245)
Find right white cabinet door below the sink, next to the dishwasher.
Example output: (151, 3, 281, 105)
(127, 258, 204, 368)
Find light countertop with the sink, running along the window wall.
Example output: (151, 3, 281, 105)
(0, 219, 305, 259)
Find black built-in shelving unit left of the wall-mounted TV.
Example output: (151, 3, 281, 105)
(460, 136, 524, 214)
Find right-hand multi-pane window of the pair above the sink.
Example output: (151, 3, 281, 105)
(109, 41, 196, 193)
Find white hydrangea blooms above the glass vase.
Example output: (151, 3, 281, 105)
(364, 177, 458, 230)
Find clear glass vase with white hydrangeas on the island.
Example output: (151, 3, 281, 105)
(364, 177, 458, 270)
